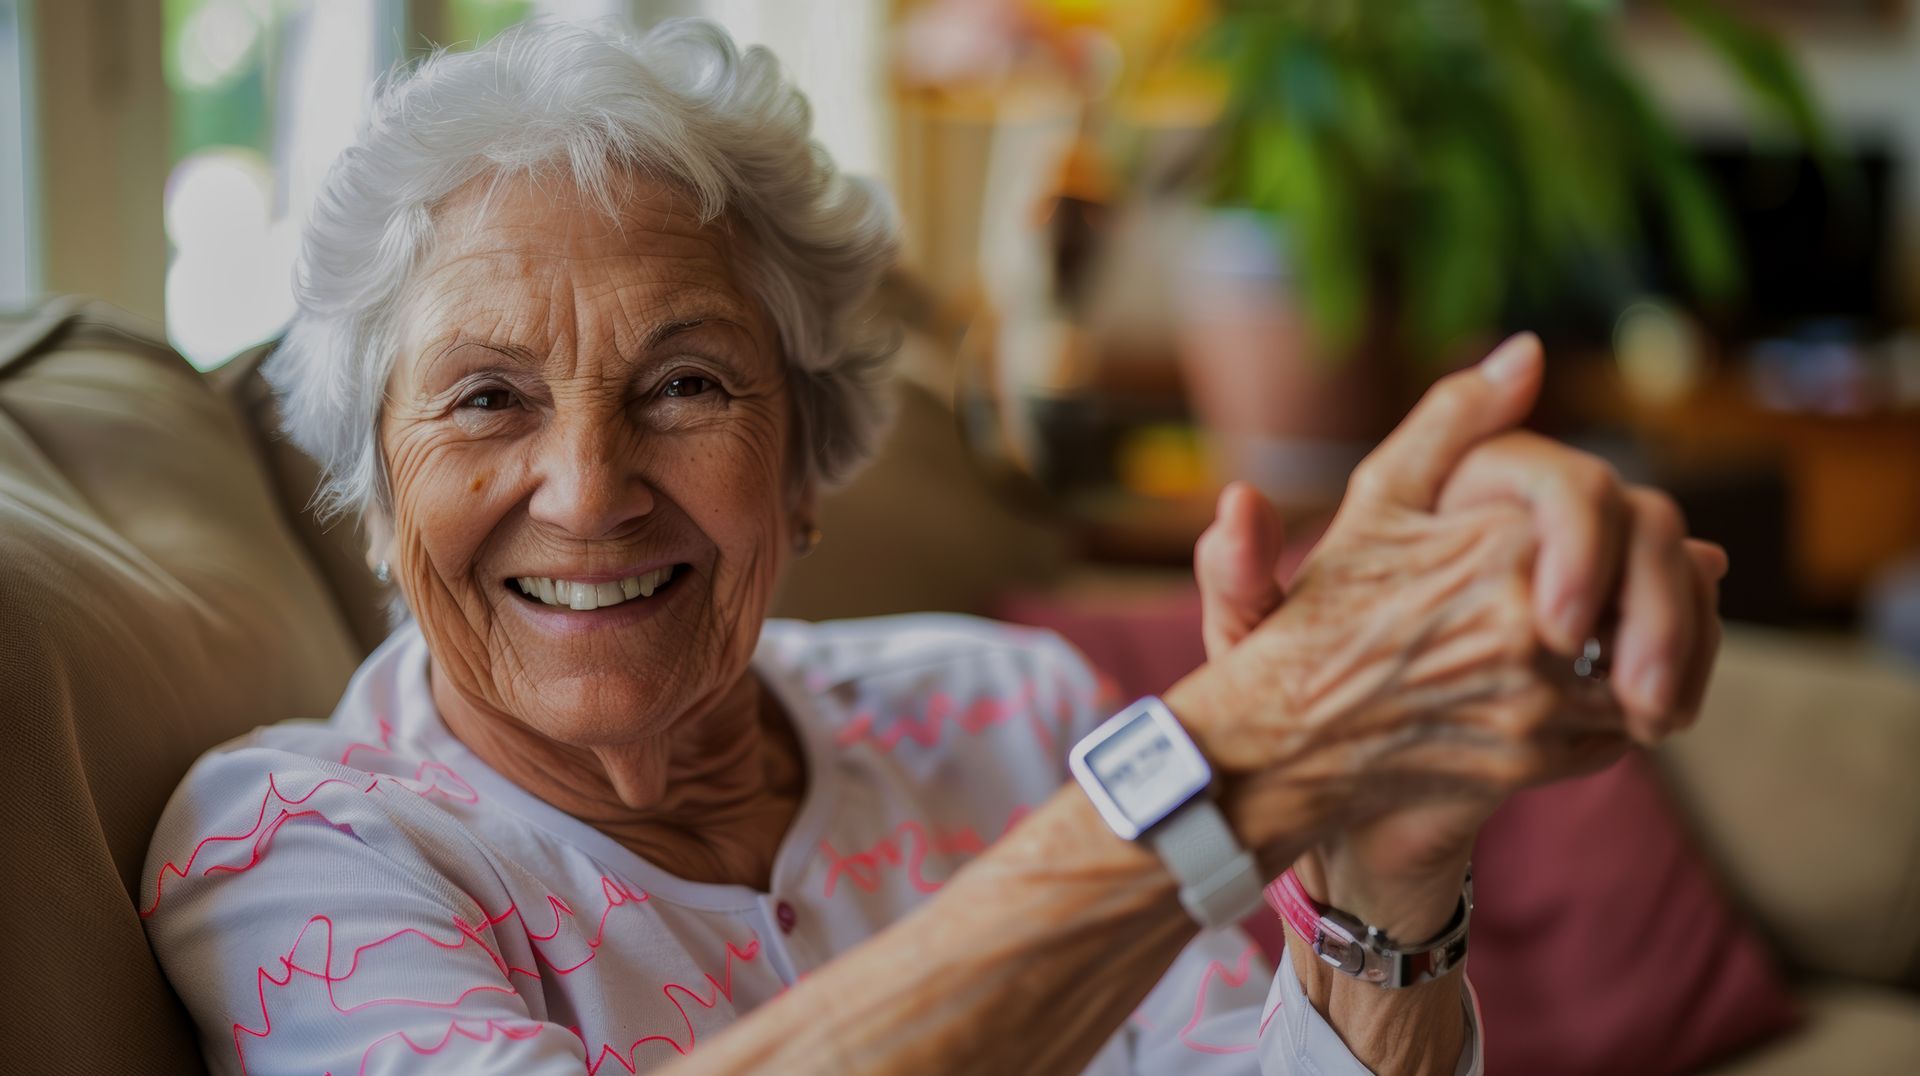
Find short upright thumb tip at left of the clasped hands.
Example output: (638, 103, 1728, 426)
(1194, 482, 1283, 661)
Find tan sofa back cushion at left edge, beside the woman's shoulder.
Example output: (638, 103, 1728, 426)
(0, 302, 357, 1072)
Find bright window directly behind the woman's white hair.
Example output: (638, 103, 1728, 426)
(159, 0, 883, 369)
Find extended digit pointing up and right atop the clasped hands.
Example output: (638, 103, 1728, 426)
(1350, 332, 1544, 511)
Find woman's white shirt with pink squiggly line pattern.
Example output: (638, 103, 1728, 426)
(140, 615, 1480, 1076)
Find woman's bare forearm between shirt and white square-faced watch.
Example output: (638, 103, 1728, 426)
(675, 786, 1196, 1074)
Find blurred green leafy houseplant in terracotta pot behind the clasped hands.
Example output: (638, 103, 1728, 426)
(1152, 0, 1832, 513)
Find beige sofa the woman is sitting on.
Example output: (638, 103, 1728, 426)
(0, 300, 1920, 1074)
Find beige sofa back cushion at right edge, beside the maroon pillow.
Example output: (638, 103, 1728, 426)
(1661, 628, 1920, 986)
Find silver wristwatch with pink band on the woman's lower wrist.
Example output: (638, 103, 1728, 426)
(1267, 870, 1473, 988)
